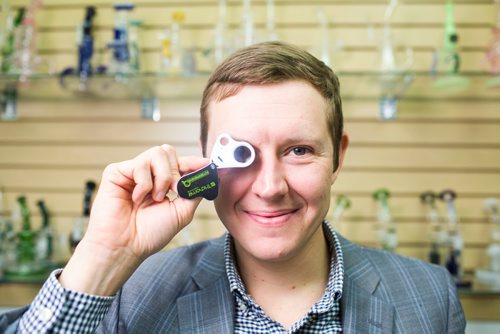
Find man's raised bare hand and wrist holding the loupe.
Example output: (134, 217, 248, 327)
(59, 145, 208, 295)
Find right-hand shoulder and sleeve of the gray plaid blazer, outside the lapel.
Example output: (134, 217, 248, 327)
(356, 245, 465, 333)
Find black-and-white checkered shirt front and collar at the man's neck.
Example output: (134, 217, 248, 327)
(224, 221, 344, 334)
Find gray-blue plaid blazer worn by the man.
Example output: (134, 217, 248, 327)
(0, 236, 465, 334)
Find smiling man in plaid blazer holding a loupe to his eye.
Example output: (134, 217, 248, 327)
(0, 43, 465, 333)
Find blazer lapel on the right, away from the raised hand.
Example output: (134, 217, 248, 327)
(339, 236, 394, 334)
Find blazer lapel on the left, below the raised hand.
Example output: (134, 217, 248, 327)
(177, 236, 234, 334)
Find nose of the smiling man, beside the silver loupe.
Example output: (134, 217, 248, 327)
(252, 154, 288, 200)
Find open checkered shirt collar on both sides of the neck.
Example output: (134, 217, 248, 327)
(224, 220, 344, 313)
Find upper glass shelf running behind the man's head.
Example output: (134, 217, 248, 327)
(0, 72, 500, 101)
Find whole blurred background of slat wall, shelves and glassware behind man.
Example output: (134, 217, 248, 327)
(0, 0, 500, 333)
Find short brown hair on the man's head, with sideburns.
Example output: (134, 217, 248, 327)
(200, 42, 343, 170)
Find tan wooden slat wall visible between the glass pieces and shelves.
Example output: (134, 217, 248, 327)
(0, 0, 500, 270)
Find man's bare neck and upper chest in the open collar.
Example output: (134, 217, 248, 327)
(236, 226, 330, 328)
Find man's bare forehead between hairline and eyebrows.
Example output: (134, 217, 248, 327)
(207, 81, 328, 143)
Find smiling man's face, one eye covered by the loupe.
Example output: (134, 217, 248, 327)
(207, 81, 342, 261)
